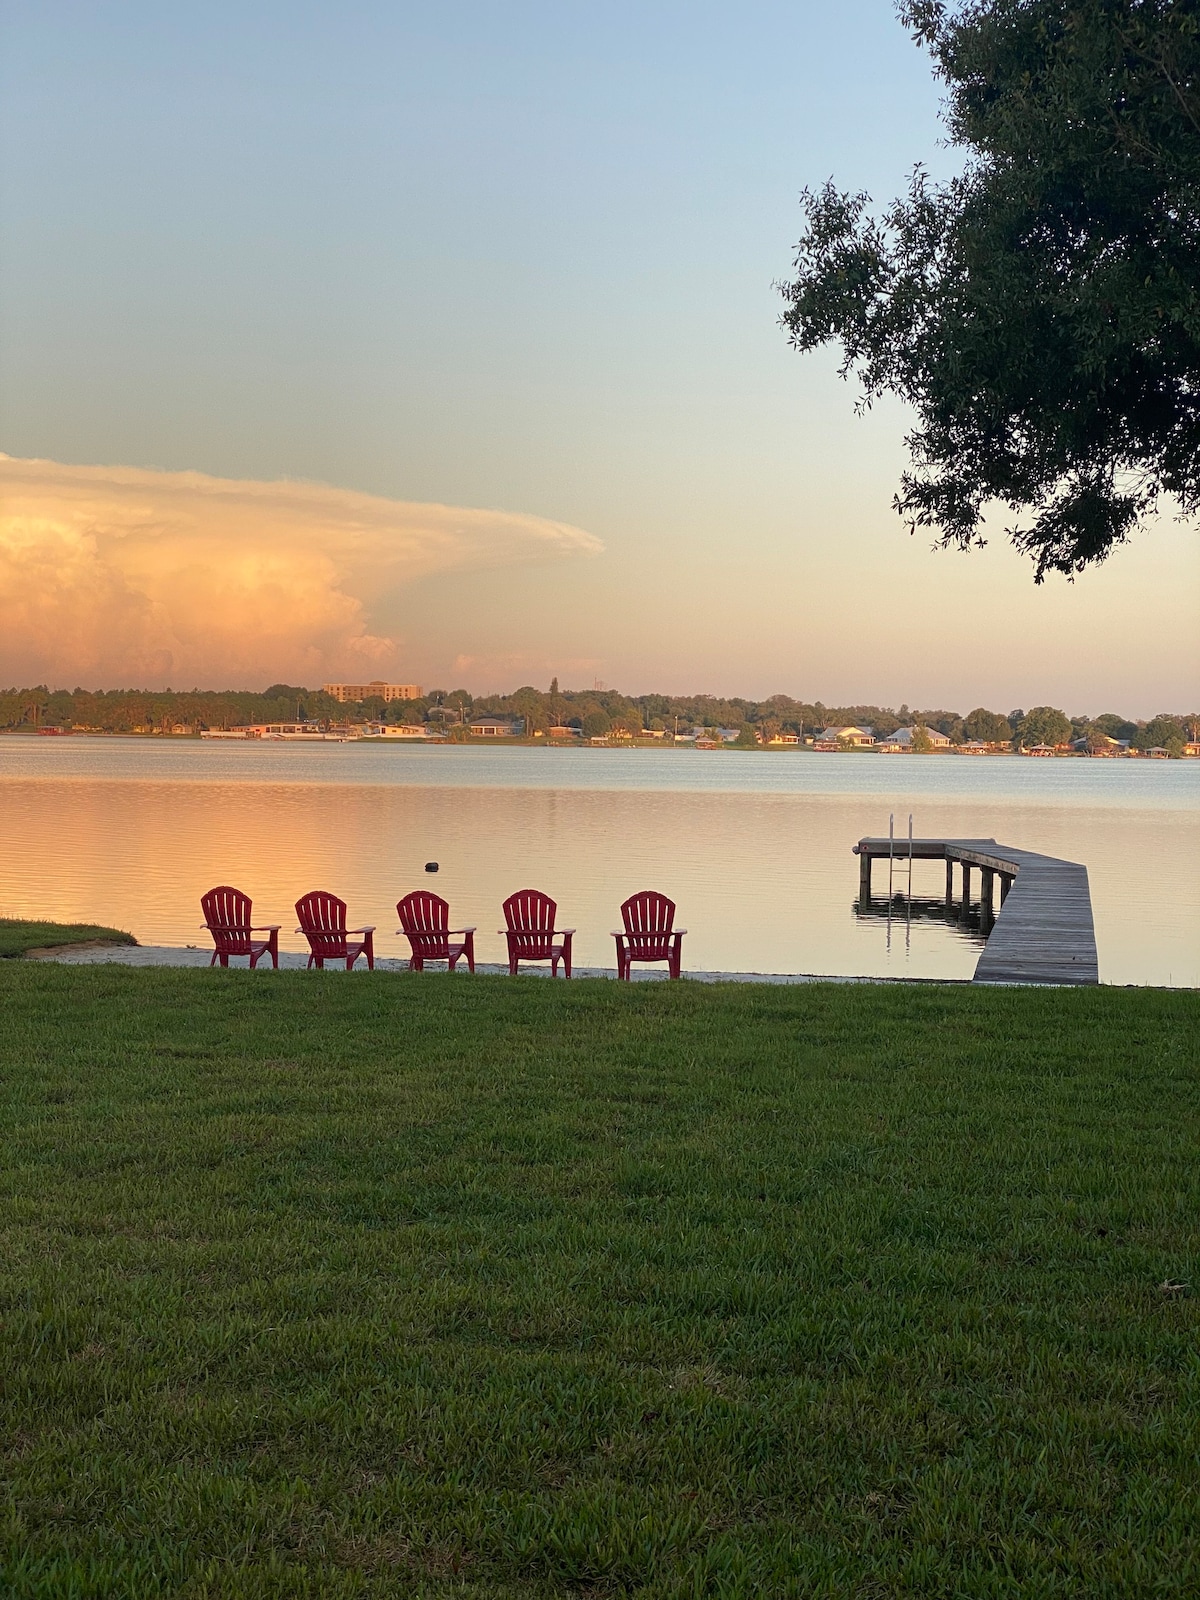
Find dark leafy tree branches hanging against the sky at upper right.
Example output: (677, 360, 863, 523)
(784, 0, 1200, 582)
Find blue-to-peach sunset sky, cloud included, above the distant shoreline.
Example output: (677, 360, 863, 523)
(0, 0, 1200, 717)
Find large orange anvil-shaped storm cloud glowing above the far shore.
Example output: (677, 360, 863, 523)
(0, 456, 602, 688)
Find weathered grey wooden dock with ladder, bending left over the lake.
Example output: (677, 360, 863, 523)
(854, 838, 1099, 984)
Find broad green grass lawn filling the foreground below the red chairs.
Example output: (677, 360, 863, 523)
(0, 962, 1200, 1600)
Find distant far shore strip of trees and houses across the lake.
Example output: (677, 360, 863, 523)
(0, 680, 1200, 754)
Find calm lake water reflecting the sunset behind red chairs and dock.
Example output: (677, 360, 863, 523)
(0, 736, 1200, 987)
